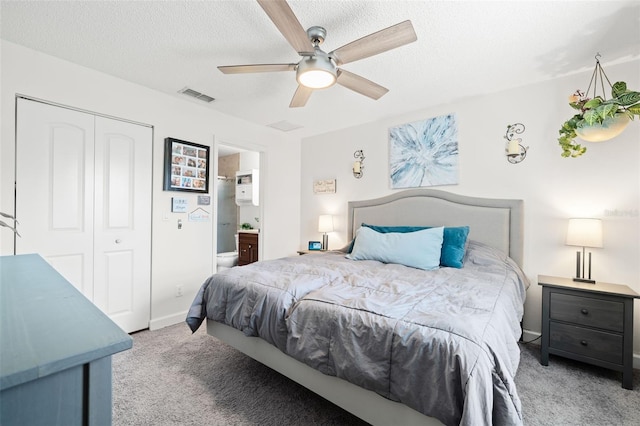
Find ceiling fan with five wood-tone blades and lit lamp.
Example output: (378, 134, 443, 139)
(218, 0, 417, 108)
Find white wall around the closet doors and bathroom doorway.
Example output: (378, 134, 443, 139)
(0, 41, 300, 327)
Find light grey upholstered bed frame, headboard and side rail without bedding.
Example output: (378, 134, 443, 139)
(207, 189, 523, 426)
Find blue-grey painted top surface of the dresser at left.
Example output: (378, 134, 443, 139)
(0, 254, 133, 390)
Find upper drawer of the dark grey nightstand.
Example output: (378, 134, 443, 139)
(550, 292, 624, 333)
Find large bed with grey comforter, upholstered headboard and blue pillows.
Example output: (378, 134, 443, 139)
(187, 189, 529, 425)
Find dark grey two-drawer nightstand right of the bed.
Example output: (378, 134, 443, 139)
(538, 275, 640, 389)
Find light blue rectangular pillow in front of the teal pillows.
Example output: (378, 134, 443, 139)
(346, 226, 444, 270)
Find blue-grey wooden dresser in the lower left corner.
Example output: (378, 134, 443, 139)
(0, 254, 133, 426)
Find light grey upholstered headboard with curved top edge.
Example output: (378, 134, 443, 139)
(347, 189, 524, 267)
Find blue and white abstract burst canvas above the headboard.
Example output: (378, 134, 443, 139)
(389, 114, 458, 189)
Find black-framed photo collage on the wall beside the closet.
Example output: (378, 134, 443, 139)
(163, 138, 209, 193)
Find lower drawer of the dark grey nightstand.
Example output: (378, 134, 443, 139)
(549, 321, 622, 365)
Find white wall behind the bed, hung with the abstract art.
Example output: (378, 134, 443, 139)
(300, 61, 640, 354)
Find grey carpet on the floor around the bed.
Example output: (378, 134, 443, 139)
(113, 324, 640, 426)
